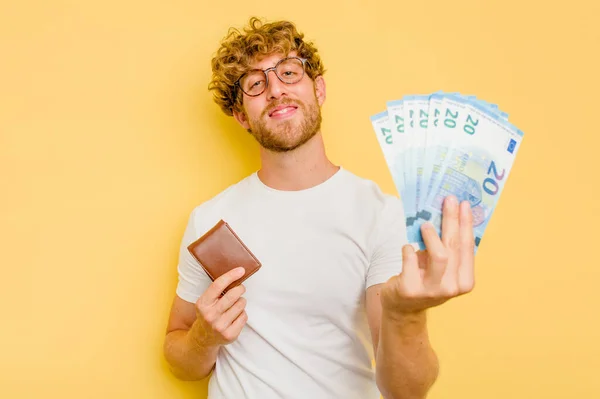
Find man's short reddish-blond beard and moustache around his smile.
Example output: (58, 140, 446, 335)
(248, 96, 321, 152)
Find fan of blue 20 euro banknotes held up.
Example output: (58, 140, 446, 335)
(371, 91, 523, 252)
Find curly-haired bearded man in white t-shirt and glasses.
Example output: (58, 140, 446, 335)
(165, 19, 474, 399)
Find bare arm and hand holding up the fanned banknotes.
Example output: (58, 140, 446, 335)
(367, 197, 474, 399)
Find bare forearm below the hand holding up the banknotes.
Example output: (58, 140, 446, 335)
(376, 311, 439, 399)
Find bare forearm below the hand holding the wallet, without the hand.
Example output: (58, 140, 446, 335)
(164, 326, 219, 381)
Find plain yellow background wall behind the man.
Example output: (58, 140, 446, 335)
(0, 0, 600, 399)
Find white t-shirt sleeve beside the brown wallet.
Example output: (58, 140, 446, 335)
(175, 209, 212, 303)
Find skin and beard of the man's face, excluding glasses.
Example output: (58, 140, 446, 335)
(234, 53, 325, 152)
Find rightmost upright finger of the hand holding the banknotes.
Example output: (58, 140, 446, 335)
(458, 201, 475, 293)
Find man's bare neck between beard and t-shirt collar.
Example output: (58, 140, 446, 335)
(258, 133, 339, 191)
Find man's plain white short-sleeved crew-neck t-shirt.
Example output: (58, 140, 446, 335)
(177, 168, 407, 399)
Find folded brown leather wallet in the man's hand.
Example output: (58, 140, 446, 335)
(187, 220, 262, 295)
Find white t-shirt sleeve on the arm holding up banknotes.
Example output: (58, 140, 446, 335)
(366, 195, 408, 288)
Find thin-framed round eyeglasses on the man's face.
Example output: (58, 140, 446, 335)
(235, 57, 307, 97)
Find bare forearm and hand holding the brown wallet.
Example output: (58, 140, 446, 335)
(163, 268, 248, 380)
